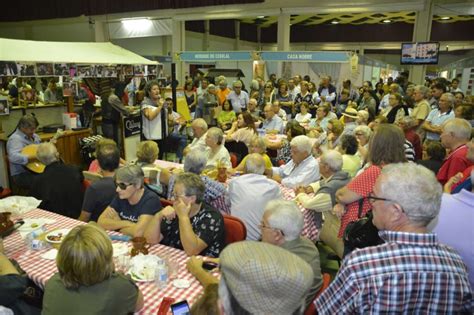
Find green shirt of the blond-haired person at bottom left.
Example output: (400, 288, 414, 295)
(42, 273, 138, 315)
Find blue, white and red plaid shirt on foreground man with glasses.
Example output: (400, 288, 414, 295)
(314, 231, 474, 314)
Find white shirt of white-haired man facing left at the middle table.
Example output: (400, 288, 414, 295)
(272, 155, 320, 188)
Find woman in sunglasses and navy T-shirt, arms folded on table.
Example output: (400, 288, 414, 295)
(97, 165, 161, 236)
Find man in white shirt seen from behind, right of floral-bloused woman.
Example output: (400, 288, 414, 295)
(229, 153, 281, 241)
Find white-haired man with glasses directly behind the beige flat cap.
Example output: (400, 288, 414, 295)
(260, 200, 323, 305)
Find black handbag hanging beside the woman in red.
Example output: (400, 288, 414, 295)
(344, 198, 383, 251)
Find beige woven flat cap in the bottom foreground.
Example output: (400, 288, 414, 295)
(219, 241, 313, 314)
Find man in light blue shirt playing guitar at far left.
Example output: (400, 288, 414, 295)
(7, 114, 41, 189)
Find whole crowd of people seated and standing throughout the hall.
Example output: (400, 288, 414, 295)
(0, 73, 474, 314)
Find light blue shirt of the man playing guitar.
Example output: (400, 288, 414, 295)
(7, 129, 41, 176)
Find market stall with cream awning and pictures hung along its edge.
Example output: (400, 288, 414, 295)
(0, 38, 158, 187)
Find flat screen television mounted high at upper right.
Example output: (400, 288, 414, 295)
(400, 42, 439, 65)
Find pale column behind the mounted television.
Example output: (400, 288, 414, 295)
(409, 0, 434, 84)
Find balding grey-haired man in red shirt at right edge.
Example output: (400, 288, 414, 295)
(436, 118, 473, 185)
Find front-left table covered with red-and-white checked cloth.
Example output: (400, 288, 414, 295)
(4, 209, 204, 314)
